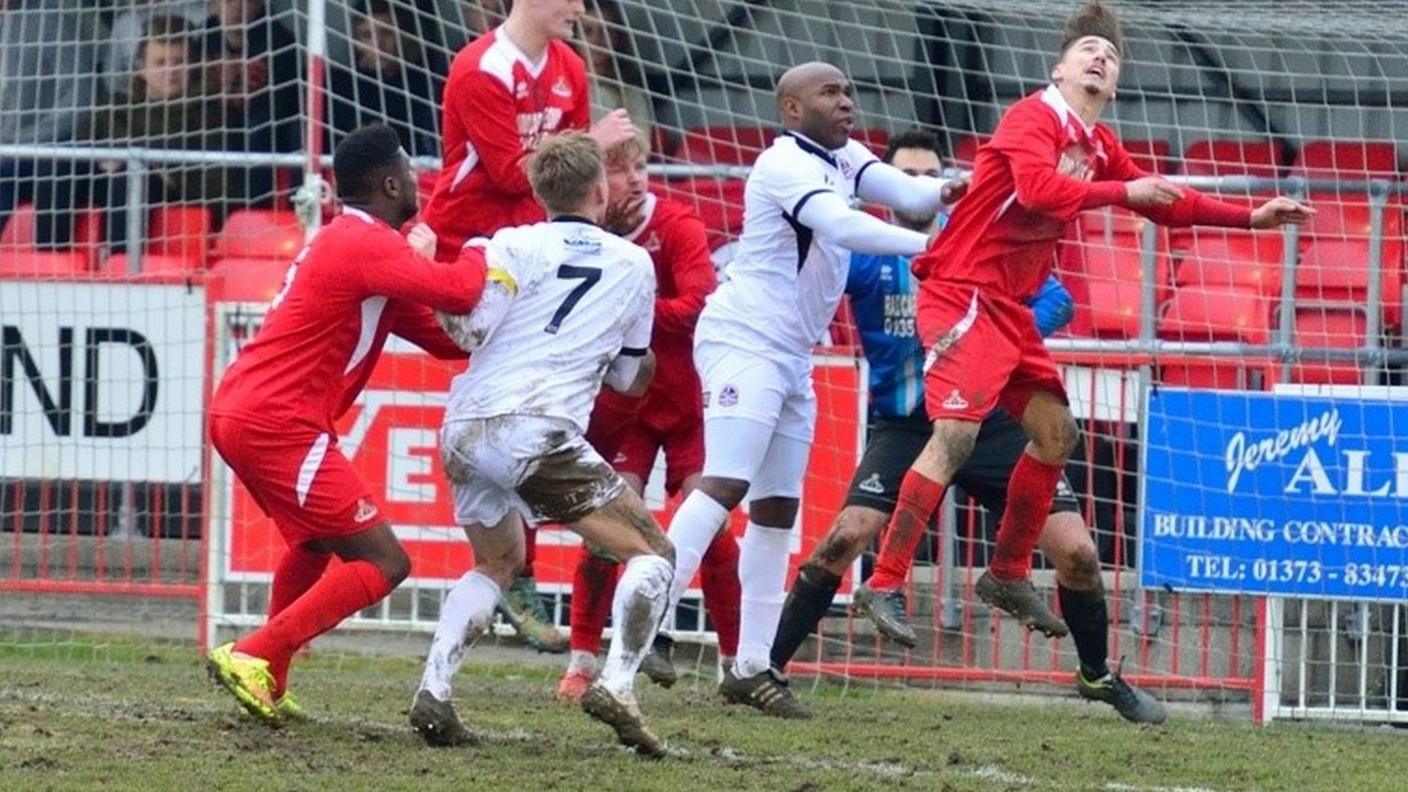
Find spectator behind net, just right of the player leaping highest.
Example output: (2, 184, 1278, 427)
(577, 0, 655, 141)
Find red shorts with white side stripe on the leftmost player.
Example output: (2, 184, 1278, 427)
(210, 416, 383, 545)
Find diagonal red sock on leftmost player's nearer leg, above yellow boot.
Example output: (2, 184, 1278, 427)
(235, 561, 391, 696)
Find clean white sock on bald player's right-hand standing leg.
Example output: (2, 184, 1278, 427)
(734, 521, 791, 676)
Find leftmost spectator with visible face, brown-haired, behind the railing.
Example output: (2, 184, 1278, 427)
(76, 16, 237, 251)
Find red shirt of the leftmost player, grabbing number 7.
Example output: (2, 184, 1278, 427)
(210, 209, 484, 433)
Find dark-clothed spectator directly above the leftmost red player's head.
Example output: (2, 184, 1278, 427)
(328, 0, 444, 156)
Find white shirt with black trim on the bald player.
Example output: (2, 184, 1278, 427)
(694, 131, 879, 355)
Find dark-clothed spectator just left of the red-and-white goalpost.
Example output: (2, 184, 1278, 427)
(200, 0, 303, 203)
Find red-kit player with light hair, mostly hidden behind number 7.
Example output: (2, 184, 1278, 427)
(558, 138, 739, 702)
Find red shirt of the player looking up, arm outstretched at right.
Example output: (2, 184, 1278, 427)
(912, 86, 1252, 302)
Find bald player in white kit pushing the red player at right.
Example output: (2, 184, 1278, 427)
(658, 62, 966, 717)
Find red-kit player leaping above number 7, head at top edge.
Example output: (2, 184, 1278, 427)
(424, 0, 636, 652)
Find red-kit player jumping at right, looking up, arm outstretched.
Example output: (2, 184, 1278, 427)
(869, 0, 1314, 636)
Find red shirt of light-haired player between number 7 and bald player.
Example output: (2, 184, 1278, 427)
(603, 194, 717, 431)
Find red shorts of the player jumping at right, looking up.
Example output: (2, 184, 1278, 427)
(915, 283, 1066, 423)
